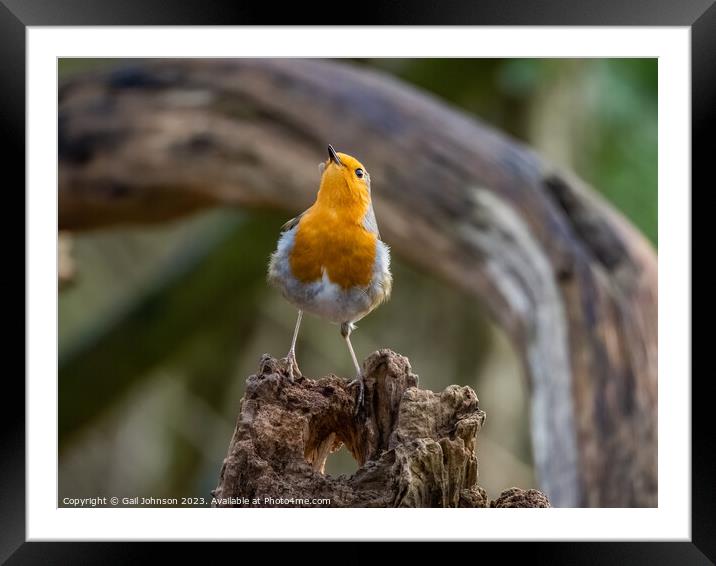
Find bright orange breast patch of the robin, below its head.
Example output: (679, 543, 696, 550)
(290, 206, 377, 289)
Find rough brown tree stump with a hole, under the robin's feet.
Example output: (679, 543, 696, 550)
(212, 350, 549, 507)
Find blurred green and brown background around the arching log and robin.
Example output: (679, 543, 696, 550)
(59, 59, 657, 504)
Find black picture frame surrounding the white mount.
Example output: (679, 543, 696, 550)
(0, 0, 704, 565)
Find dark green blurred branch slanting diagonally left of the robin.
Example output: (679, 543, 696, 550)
(58, 215, 281, 450)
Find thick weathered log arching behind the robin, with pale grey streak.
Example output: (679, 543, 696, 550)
(59, 59, 657, 506)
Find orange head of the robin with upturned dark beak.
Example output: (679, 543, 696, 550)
(319, 145, 370, 209)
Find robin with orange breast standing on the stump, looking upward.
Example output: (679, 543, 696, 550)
(267, 145, 393, 411)
